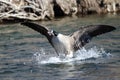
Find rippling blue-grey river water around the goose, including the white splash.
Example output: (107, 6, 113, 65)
(0, 14, 120, 80)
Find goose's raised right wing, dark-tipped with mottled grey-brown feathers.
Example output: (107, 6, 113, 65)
(71, 25, 116, 51)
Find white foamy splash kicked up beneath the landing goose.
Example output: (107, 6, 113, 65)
(33, 47, 111, 64)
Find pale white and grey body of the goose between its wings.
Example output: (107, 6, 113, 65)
(52, 33, 74, 57)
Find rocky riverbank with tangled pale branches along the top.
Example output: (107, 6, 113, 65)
(0, 0, 120, 21)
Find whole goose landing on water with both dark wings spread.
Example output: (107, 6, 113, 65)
(21, 22, 115, 57)
